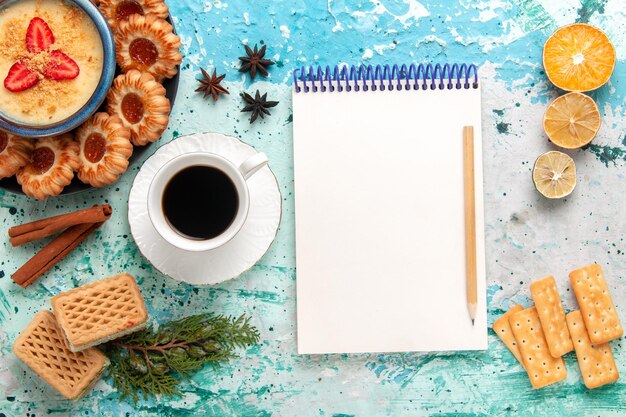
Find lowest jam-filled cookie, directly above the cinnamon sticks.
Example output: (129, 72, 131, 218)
(17, 133, 80, 200)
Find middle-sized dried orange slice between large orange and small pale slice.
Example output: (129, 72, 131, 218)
(543, 92, 601, 149)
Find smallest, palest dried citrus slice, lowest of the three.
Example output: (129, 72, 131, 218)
(533, 151, 576, 198)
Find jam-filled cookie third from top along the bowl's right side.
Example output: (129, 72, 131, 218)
(107, 70, 170, 146)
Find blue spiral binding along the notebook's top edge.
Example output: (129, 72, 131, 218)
(293, 64, 478, 93)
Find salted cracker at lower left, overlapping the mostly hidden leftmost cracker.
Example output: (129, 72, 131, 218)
(509, 307, 567, 389)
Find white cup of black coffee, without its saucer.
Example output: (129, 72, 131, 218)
(148, 152, 268, 251)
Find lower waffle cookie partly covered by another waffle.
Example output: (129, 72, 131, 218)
(13, 310, 109, 399)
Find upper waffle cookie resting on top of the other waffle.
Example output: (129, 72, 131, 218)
(51, 274, 148, 352)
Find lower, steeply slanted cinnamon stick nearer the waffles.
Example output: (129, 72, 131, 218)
(11, 222, 104, 287)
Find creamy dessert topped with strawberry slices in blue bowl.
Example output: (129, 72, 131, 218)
(0, 0, 115, 137)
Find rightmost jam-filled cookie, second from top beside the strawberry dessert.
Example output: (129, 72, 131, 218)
(115, 14, 183, 81)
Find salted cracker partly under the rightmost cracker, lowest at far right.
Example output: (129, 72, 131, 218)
(567, 311, 619, 389)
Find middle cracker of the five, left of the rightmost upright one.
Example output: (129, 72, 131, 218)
(530, 276, 574, 358)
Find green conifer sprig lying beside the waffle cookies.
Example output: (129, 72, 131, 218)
(104, 314, 259, 403)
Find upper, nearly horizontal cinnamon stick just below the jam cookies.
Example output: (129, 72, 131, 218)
(9, 204, 113, 246)
